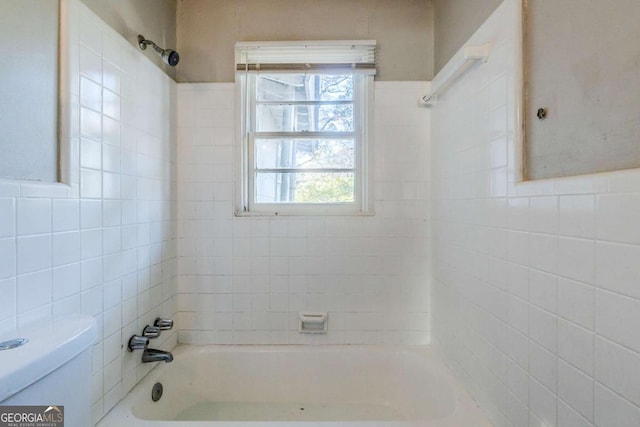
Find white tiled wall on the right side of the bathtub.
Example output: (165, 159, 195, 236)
(432, 0, 640, 427)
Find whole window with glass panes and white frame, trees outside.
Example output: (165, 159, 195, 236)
(236, 44, 375, 214)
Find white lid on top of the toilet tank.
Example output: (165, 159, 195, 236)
(0, 314, 97, 402)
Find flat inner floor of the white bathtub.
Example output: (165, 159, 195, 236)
(175, 402, 406, 421)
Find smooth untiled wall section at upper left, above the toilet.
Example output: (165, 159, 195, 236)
(0, 0, 60, 182)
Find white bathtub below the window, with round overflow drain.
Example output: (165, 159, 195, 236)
(98, 346, 491, 427)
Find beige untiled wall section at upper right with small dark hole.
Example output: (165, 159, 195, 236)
(524, 0, 640, 180)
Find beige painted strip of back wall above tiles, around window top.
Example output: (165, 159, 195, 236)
(177, 0, 433, 83)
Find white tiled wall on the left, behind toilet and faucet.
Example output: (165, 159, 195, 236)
(0, 1, 177, 420)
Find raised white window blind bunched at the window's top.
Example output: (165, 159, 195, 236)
(235, 40, 376, 75)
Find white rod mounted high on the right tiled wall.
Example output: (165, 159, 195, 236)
(421, 43, 489, 105)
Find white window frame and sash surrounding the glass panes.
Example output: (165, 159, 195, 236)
(235, 41, 374, 216)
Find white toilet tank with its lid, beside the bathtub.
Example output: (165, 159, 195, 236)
(0, 315, 97, 427)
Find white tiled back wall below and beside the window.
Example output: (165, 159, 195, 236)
(178, 82, 430, 344)
